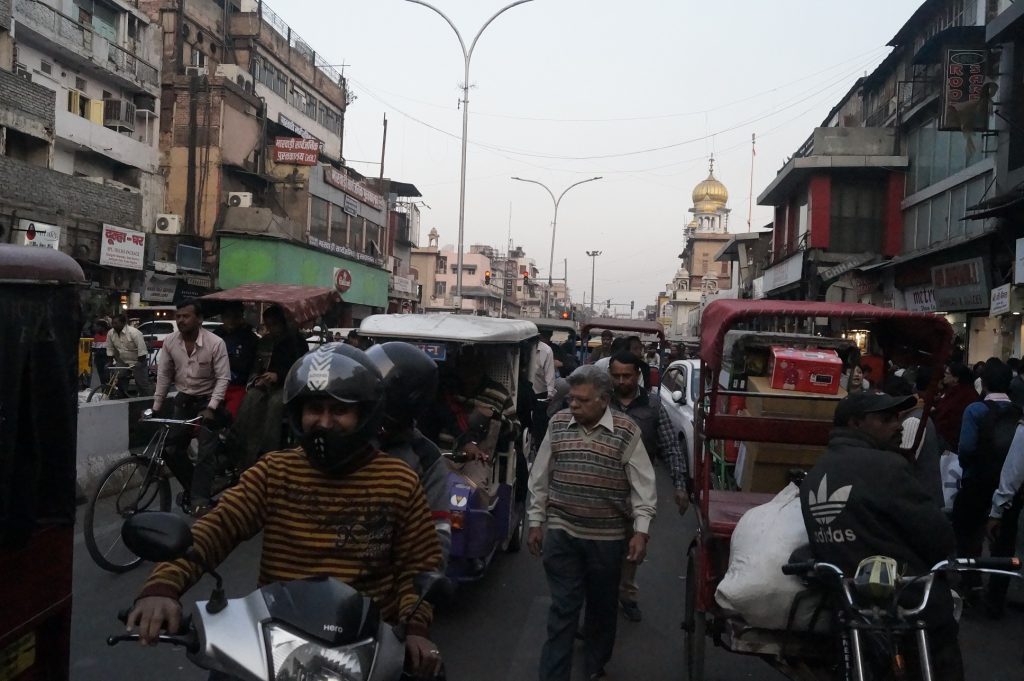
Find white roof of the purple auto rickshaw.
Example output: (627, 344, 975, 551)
(359, 312, 538, 343)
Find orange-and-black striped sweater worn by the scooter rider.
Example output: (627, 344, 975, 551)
(139, 450, 441, 634)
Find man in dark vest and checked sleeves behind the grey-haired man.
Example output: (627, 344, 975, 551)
(608, 351, 690, 622)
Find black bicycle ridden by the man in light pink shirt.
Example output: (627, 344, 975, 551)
(84, 410, 240, 573)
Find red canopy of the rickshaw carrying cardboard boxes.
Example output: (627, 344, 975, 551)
(699, 300, 953, 369)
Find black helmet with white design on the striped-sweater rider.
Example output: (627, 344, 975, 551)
(285, 343, 383, 475)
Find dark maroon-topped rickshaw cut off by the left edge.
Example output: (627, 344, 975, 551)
(0, 244, 85, 681)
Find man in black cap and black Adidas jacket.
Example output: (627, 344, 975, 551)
(800, 390, 964, 681)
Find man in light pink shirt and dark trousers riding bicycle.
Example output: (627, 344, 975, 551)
(153, 300, 231, 517)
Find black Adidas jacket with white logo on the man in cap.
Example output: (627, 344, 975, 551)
(800, 428, 955, 577)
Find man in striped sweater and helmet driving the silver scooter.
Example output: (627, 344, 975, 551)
(128, 345, 441, 675)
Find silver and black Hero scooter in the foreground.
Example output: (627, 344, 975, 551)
(106, 512, 451, 681)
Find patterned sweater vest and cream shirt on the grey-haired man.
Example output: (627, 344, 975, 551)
(528, 410, 656, 540)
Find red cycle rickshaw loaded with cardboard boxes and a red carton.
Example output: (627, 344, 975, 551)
(683, 300, 952, 681)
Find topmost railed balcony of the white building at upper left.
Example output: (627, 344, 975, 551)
(14, 0, 160, 96)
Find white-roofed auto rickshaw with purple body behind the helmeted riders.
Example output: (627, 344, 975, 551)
(359, 313, 538, 582)
